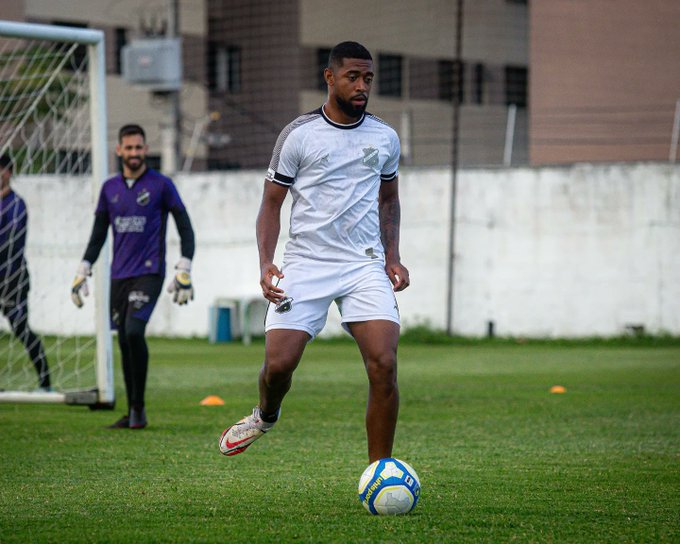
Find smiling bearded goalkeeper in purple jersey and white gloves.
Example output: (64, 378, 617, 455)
(71, 125, 194, 429)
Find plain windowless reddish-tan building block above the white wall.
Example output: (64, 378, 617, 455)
(529, 0, 680, 165)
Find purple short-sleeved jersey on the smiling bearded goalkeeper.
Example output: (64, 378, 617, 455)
(95, 168, 185, 279)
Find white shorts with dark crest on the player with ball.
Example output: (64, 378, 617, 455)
(265, 259, 399, 338)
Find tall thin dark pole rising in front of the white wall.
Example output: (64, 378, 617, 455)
(446, 0, 463, 335)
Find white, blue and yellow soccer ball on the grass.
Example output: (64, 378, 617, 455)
(359, 457, 420, 515)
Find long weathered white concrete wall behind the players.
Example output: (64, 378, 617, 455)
(11, 164, 680, 337)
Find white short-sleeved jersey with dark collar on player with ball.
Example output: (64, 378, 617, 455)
(267, 108, 400, 262)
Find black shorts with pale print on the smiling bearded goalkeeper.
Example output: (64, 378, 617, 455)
(111, 274, 163, 329)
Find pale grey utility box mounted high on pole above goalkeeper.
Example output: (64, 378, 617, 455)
(121, 38, 182, 91)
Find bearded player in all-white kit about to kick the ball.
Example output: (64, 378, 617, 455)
(220, 42, 409, 462)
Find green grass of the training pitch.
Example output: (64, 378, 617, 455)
(0, 338, 680, 544)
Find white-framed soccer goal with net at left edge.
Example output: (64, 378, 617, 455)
(0, 21, 114, 407)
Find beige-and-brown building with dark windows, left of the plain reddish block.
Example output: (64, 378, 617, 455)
(0, 0, 529, 170)
